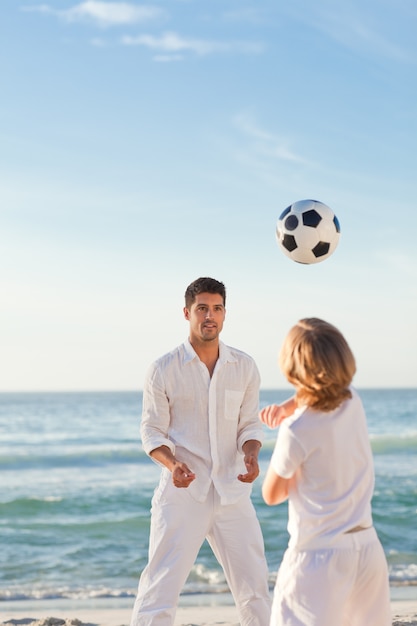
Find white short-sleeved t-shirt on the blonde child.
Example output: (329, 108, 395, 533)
(271, 388, 374, 549)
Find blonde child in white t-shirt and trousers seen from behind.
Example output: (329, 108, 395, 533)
(260, 318, 391, 626)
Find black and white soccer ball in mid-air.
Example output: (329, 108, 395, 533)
(276, 200, 340, 264)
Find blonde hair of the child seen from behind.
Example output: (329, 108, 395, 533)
(279, 317, 356, 411)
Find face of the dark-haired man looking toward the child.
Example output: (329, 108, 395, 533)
(184, 293, 226, 342)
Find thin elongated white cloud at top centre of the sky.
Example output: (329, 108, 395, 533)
(122, 32, 262, 60)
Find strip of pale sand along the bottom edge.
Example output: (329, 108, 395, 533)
(0, 600, 417, 626)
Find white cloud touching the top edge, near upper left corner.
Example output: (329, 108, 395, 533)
(25, 0, 164, 26)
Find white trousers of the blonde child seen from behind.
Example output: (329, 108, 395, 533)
(270, 528, 392, 626)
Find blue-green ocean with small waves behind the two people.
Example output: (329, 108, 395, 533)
(0, 389, 417, 603)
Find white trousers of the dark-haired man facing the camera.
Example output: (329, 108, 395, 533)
(131, 481, 271, 626)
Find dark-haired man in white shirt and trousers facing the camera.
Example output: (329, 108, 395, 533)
(131, 278, 270, 626)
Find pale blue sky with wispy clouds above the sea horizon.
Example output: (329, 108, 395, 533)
(0, 0, 417, 390)
